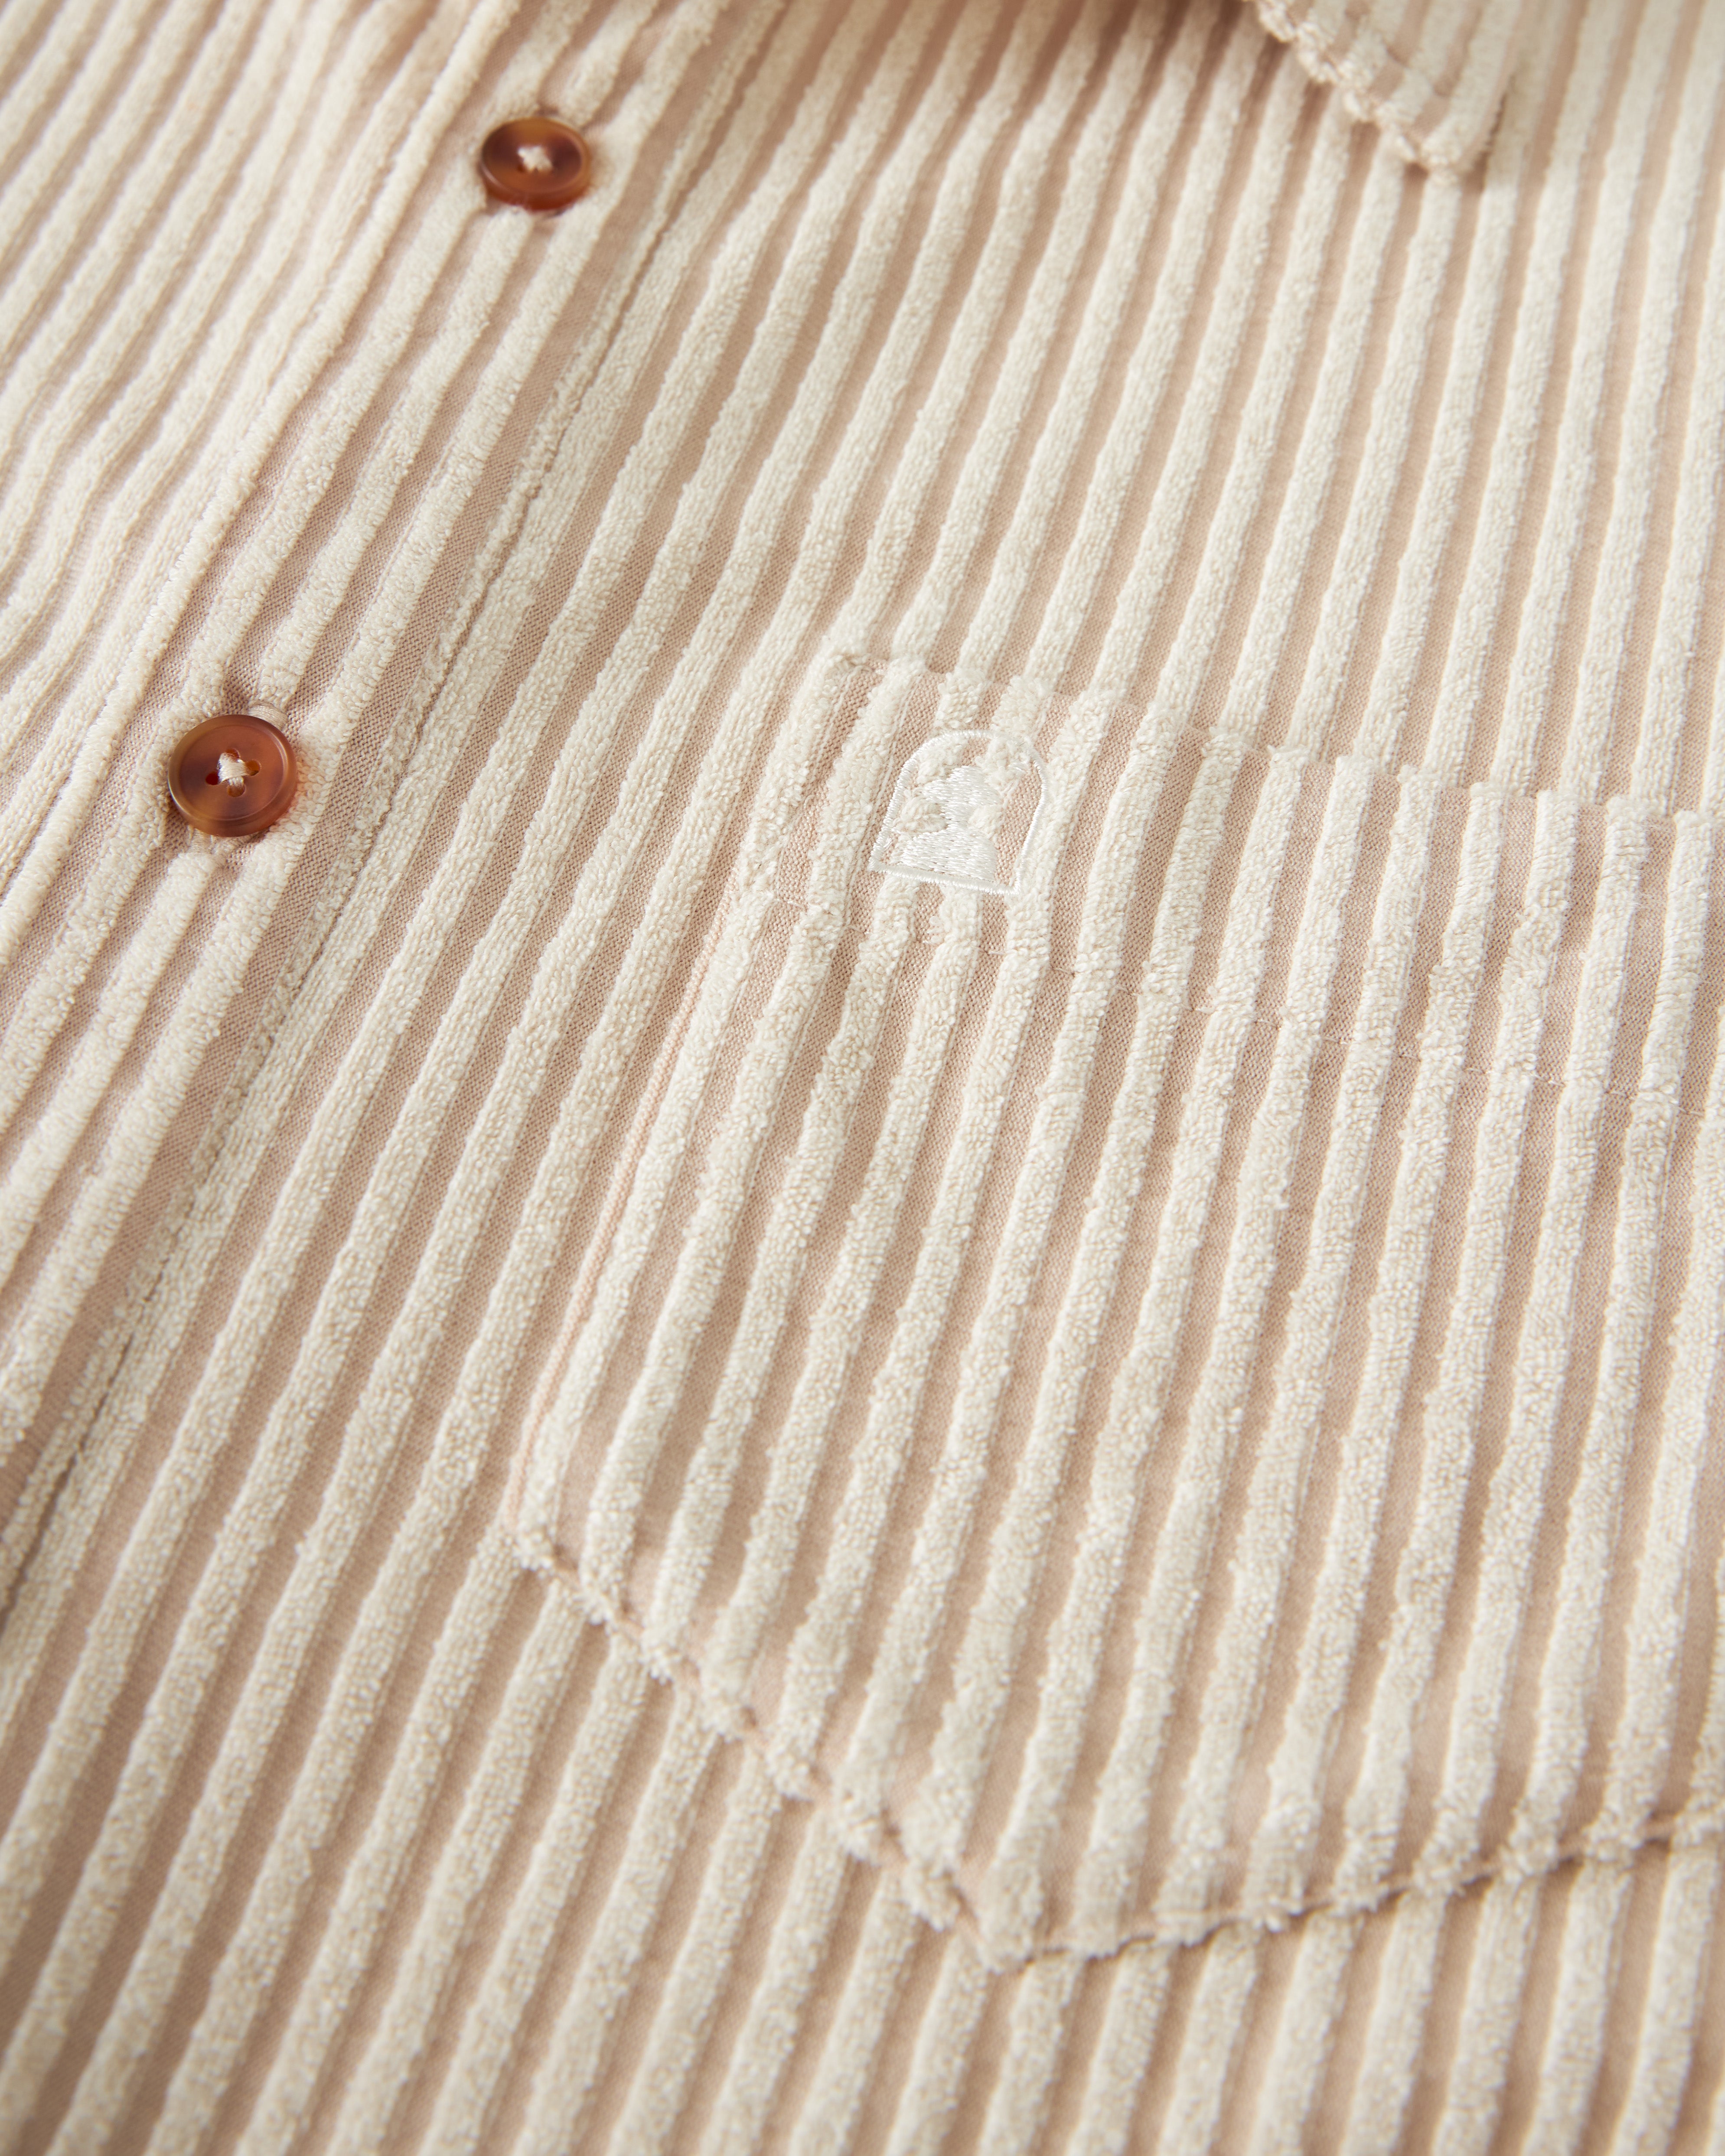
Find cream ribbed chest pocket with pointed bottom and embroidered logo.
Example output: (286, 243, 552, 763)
(520, 642, 1716, 1962)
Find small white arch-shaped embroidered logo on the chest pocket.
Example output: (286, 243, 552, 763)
(869, 731, 1048, 892)
